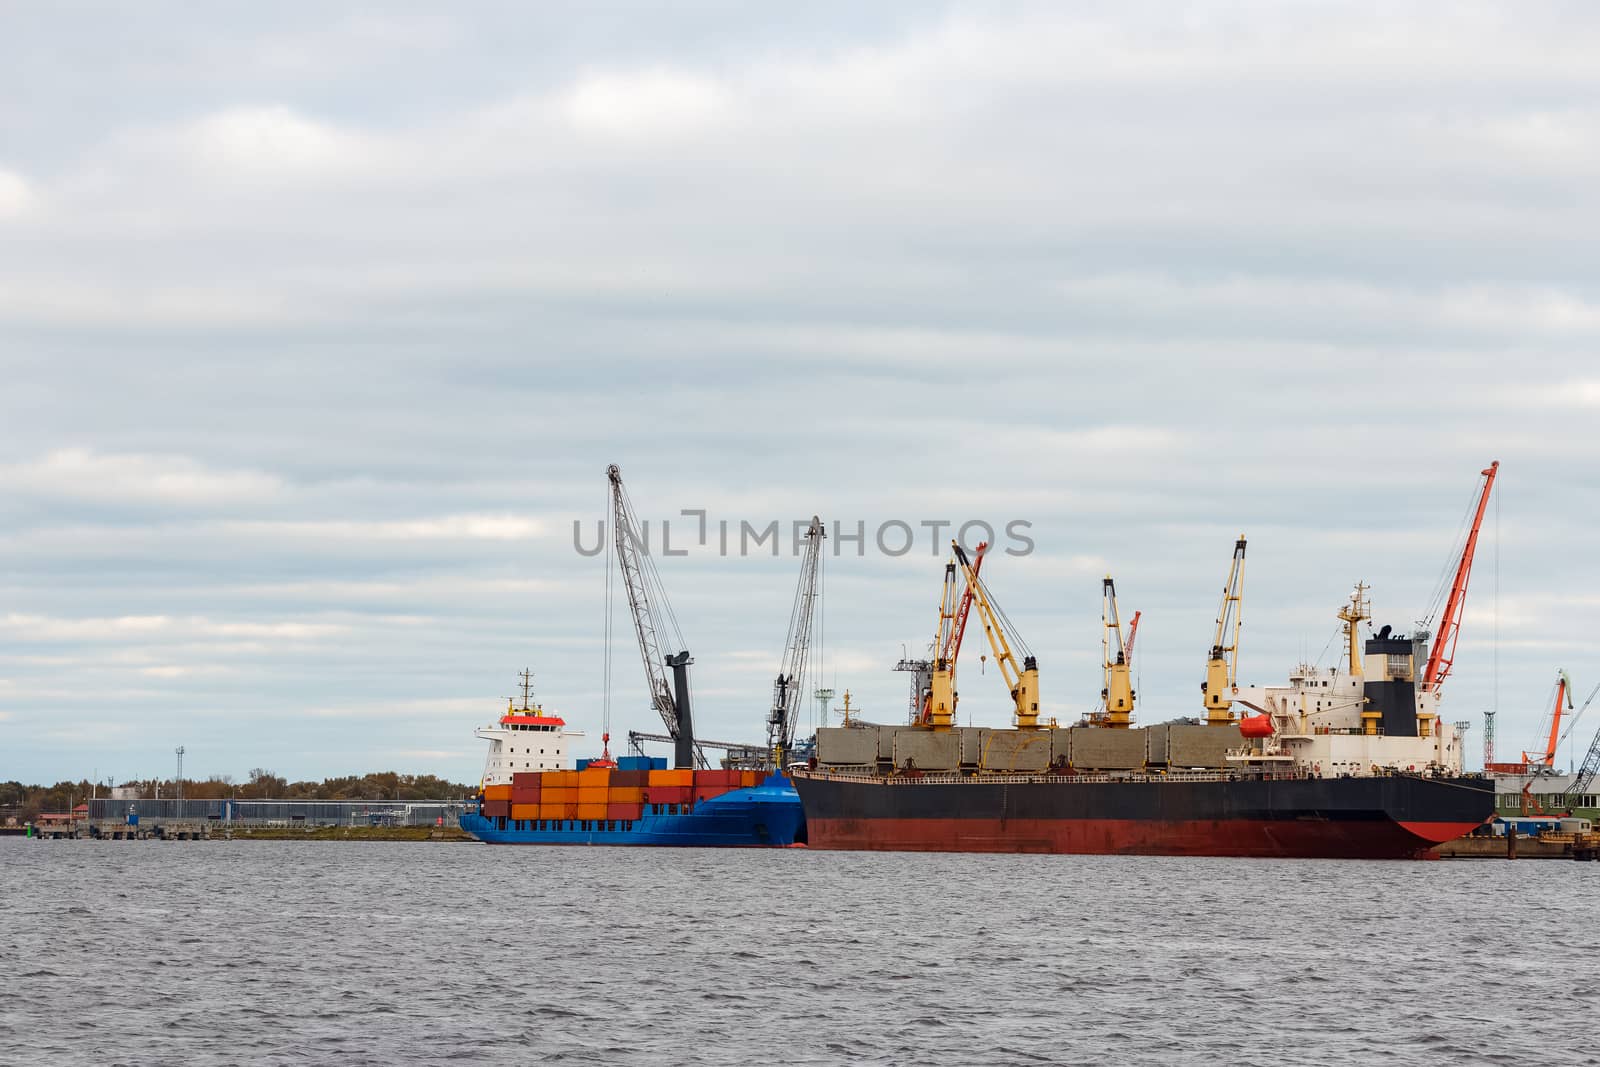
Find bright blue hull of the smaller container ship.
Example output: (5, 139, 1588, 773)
(461, 774, 805, 848)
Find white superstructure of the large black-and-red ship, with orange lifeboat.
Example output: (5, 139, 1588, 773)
(1229, 585, 1464, 777)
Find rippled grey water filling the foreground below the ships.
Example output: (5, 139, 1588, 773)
(0, 838, 1600, 1067)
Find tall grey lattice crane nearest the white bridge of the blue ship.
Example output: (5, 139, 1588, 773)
(606, 464, 706, 768)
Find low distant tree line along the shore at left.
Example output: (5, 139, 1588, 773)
(0, 766, 475, 822)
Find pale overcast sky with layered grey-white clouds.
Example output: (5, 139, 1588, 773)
(0, 2, 1600, 781)
